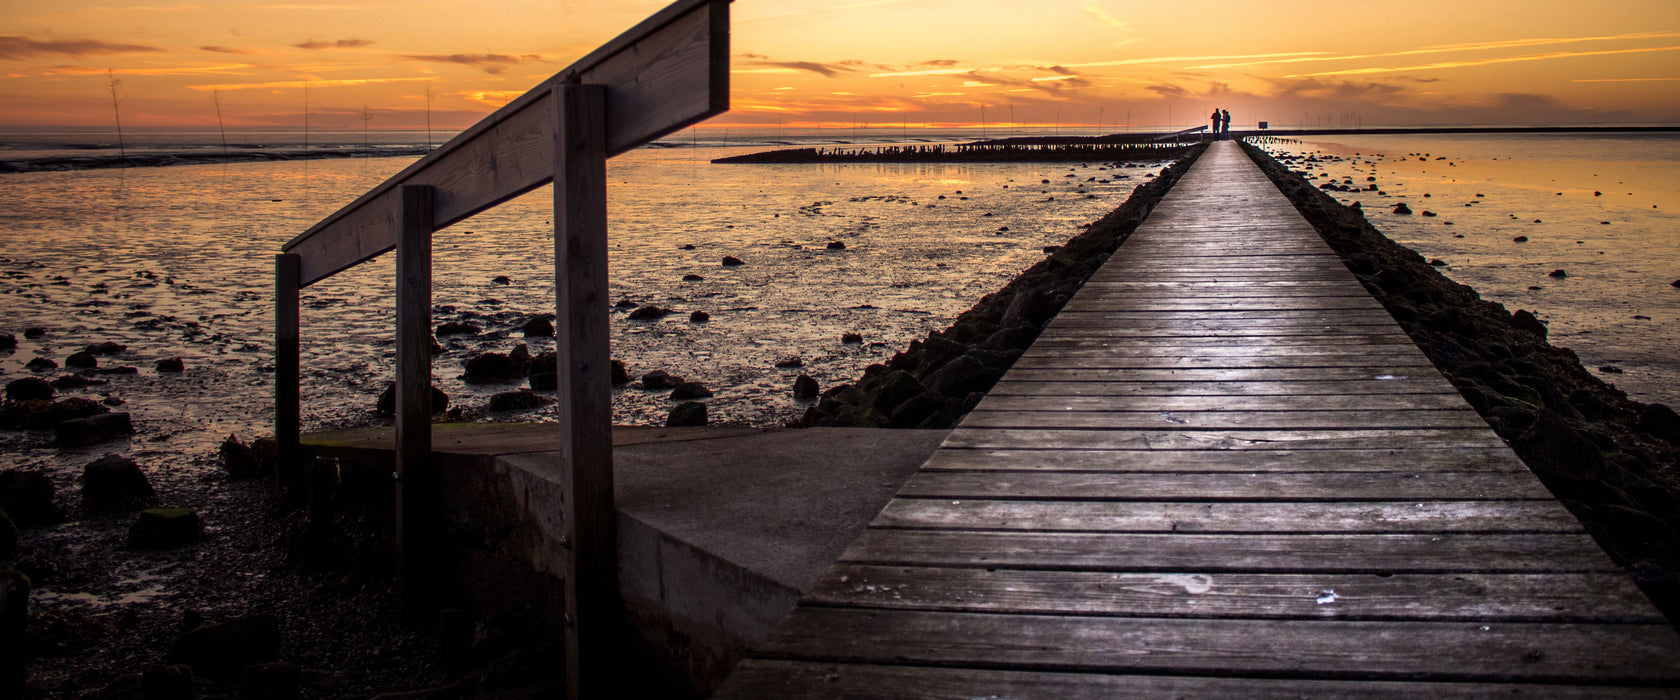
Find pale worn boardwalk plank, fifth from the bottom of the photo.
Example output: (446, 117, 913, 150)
(870, 494, 1583, 534)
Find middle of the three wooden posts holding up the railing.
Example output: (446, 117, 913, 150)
(396, 185, 437, 623)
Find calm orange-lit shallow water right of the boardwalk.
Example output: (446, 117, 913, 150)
(1267, 134, 1680, 405)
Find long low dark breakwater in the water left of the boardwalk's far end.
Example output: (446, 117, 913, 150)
(712, 143, 1189, 165)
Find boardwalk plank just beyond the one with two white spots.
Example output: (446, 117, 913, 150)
(840, 529, 1621, 574)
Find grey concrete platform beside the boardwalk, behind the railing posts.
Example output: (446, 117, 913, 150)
(304, 423, 946, 693)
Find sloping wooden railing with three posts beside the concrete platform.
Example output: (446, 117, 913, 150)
(274, 0, 731, 698)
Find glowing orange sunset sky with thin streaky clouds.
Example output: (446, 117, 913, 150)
(0, 0, 1680, 131)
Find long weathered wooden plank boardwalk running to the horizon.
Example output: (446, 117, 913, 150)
(717, 143, 1680, 698)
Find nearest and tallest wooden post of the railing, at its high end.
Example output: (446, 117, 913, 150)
(554, 84, 620, 700)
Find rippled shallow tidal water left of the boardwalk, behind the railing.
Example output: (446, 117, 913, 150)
(0, 133, 1166, 480)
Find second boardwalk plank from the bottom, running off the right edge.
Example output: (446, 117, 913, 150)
(763, 608, 1680, 683)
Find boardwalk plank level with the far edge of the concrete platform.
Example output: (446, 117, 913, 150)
(944, 428, 1505, 449)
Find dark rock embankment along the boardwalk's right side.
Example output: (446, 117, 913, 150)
(1243, 143, 1680, 623)
